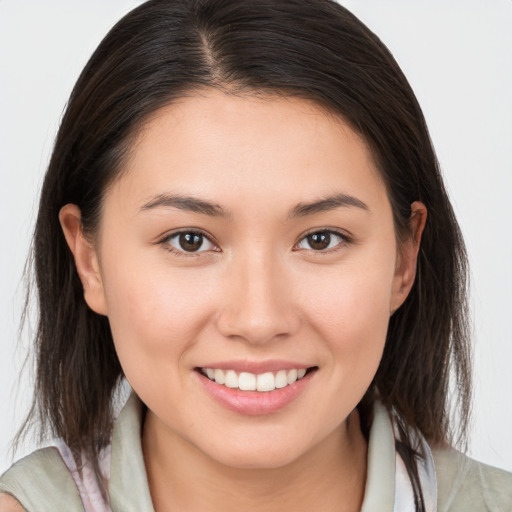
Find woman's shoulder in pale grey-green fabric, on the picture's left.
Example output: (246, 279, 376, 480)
(0, 447, 83, 512)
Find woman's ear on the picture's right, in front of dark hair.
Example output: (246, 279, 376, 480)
(390, 201, 427, 314)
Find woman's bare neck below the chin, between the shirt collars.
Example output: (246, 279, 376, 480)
(142, 412, 367, 512)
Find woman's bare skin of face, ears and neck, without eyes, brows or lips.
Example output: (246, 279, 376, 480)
(53, 90, 426, 512)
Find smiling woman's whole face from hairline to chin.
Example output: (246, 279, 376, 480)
(69, 90, 420, 467)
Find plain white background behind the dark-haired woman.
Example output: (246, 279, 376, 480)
(0, 0, 512, 472)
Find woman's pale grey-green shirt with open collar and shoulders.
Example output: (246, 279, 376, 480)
(0, 394, 512, 512)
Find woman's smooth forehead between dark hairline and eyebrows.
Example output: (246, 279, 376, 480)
(108, 89, 384, 216)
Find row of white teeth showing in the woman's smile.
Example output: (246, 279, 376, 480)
(201, 368, 306, 392)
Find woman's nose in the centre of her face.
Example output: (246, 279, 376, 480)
(217, 253, 300, 344)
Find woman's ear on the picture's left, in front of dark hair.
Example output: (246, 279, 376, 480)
(59, 204, 107, 315)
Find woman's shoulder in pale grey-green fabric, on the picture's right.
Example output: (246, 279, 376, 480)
(432, 448, 512, 512)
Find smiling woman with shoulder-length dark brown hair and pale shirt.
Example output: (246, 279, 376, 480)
(0, 0, 512, 512)
